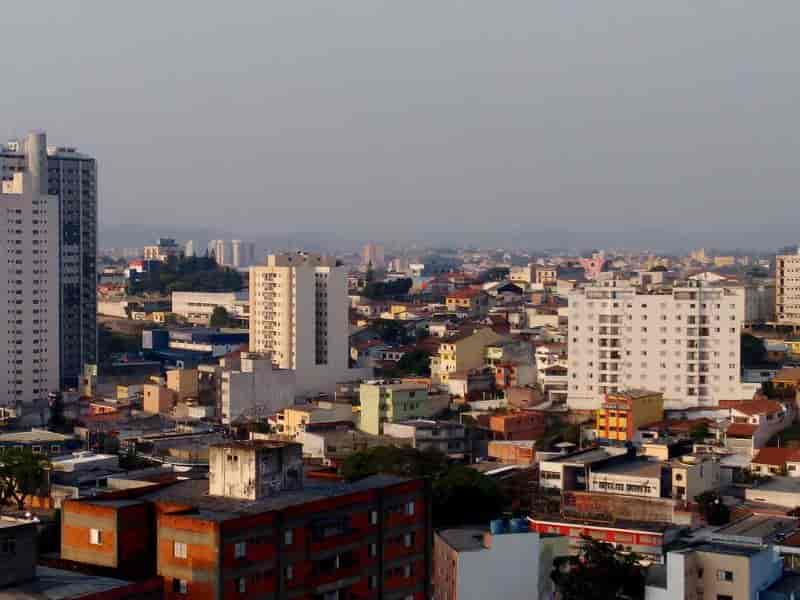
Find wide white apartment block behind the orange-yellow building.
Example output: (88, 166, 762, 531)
(567, 280, 752, 409)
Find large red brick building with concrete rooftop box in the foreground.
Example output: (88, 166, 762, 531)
(62, 442, 432, 600)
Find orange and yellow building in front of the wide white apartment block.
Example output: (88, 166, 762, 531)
(596, 390, 664, 442)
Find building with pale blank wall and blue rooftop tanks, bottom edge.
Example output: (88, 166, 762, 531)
(433, 519, 569, 600)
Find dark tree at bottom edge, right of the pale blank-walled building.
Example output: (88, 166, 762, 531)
(550, 536, 645, 600)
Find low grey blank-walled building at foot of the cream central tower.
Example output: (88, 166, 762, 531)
(220, 352, 295, 425)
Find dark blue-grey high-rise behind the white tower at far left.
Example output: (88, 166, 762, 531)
(0, 133, 97, 385)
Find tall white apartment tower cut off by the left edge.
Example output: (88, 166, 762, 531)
(0, 133, 60, 407)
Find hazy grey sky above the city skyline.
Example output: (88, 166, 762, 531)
(0, 0, 800, 248)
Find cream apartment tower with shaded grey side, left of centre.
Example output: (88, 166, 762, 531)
(250, 253, 350, 393)
